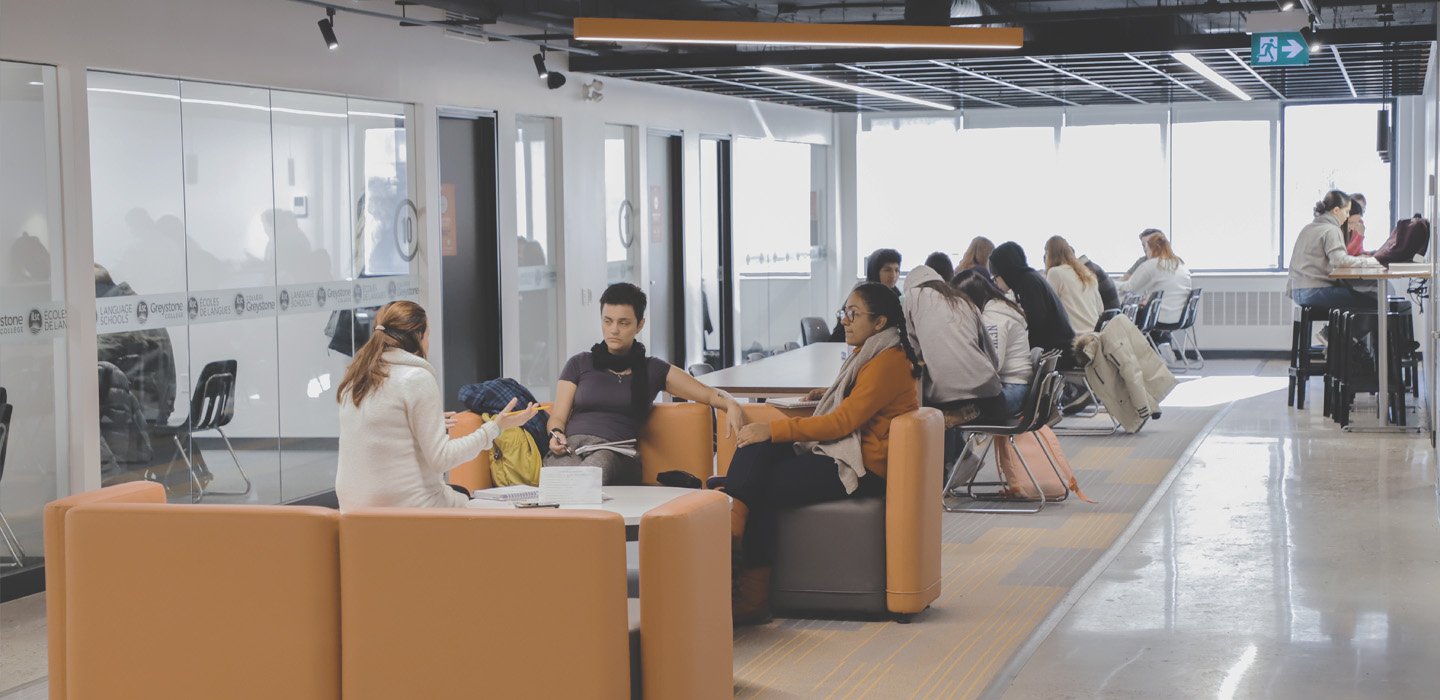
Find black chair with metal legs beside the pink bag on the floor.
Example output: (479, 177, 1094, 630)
(940, 351, 1070, 513)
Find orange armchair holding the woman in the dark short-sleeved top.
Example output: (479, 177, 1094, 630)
(449, 402, 714, 491)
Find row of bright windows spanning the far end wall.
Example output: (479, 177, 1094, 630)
(857, 102, 1391, 275)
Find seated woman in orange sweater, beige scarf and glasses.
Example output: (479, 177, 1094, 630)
(726, 282, 920, 625)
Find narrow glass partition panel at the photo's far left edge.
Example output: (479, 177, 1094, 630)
(0, 60, 69, 579)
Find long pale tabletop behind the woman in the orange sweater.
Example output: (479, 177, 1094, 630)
(696, 343, 850, 399)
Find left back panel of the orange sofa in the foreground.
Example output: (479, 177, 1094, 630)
(64, 503, 340, 700)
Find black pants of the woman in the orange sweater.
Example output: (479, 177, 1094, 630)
(726, 442, 886, 566)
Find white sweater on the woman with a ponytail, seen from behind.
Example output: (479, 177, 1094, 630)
(336, 349, 500, 511)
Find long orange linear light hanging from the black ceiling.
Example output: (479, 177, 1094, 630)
(575, 17, 1025, 49)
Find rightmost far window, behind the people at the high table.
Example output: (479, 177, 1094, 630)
(1284, 102, 1388, 251)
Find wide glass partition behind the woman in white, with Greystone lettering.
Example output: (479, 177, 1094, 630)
(88, 72, 423, 503)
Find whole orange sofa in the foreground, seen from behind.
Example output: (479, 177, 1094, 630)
(46, 484, 733, 700)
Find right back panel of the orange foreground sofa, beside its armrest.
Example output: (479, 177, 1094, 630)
(340, 508, 631, 700)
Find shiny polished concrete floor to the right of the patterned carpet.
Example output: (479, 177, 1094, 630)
(992, 363, 1440, 699)
